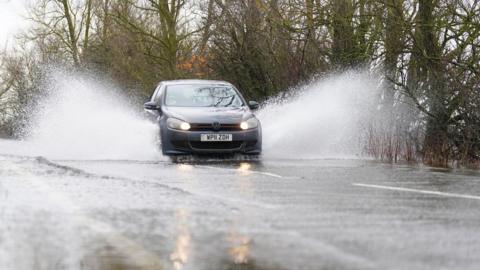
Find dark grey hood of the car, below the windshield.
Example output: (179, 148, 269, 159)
(162, 106, 253, 124)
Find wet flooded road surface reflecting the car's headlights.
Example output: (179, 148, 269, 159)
(0, 146, 480, 270)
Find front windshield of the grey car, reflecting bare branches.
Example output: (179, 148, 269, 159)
(165, 84, 243, 107)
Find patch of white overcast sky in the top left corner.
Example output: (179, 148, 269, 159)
(0, 0, 29, 48)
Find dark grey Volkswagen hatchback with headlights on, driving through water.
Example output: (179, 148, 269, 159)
(144, 80, 262, 156)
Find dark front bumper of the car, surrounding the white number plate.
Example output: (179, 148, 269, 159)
(161, 127, 262, 155)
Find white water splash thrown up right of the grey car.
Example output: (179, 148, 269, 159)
(257, 71, 379, 159)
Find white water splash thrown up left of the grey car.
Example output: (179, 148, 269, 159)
(26, 72, 160, 160)
